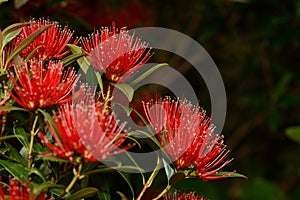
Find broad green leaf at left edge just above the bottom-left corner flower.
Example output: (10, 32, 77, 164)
(0, 160, 29, 181)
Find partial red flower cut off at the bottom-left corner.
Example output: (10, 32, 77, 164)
(0, 178, 46, 200)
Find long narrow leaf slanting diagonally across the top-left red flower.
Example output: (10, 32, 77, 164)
(5, 24, 52, 66)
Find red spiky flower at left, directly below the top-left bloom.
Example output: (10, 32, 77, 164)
(8, 60, 78, 110)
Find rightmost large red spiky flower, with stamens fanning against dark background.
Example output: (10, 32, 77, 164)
(143, 98, 232, 180)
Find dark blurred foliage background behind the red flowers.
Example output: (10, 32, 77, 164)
(0, 0, 300, 200)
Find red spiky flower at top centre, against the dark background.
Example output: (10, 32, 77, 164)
(81, 25, 152, 82)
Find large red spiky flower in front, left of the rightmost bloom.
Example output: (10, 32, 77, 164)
(39, 85, 132, 162)
